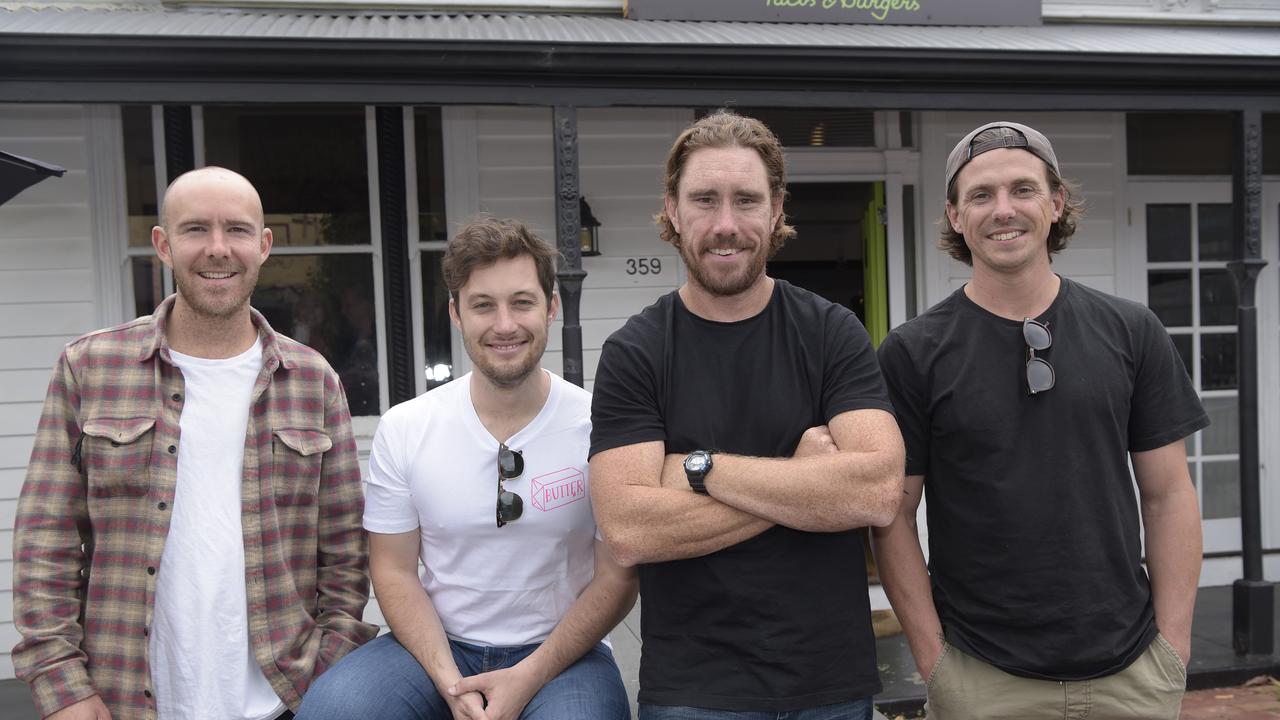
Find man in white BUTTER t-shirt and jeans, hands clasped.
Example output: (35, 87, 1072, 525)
(298, 219, 637, 720)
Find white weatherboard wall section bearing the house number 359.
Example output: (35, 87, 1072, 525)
(474, 108, 694, 388)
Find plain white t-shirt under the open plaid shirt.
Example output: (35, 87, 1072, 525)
(147, 342, 284, 720)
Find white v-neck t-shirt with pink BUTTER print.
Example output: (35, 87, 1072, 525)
(365, 373, 595, 646)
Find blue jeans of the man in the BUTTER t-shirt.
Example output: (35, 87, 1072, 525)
(297, 633, 631, 720)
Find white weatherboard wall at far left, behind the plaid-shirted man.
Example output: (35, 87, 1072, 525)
(0, 105, 99, 679)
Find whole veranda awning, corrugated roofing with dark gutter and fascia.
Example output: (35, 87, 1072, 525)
(0, 8, 1280, 111)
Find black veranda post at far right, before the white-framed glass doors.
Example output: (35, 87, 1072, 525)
(1228, 109, 1275, 655)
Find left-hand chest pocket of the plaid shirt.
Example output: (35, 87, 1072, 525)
(81, 418, 156, 497)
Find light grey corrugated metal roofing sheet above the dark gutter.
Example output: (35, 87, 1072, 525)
(0, 9, 1280, 58)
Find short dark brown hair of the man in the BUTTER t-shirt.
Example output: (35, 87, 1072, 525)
(440, 218, 559, 302)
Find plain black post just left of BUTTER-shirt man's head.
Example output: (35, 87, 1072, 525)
(374, 106, 422, 405)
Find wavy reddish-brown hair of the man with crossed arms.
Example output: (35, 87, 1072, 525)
(654, 110, 796, 258)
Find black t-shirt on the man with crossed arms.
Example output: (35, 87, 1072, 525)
(591, 281, 891, 712)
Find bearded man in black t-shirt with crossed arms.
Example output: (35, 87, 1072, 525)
(591, 107, 904, 720)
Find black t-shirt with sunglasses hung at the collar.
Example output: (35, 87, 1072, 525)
(879, 278, 1208, 680)
